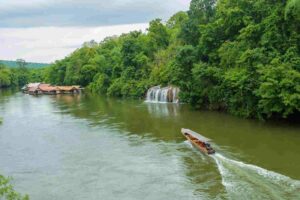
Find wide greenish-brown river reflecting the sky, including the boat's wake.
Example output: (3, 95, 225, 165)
(0, 91, 300, 200)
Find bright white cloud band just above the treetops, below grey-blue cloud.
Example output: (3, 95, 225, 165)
(0, 23, 148, 62)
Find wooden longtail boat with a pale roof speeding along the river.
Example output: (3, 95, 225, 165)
(181, 128, 215, 154)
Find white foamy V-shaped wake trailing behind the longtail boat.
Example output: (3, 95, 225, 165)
(211, 153, 300, 199)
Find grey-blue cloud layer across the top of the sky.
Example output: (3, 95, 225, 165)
(0, 0, 190, 28)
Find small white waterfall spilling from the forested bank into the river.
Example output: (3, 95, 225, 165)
(146, 86, 179, 103)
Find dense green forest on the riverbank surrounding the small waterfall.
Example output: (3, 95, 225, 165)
(2, 0, 300, 119)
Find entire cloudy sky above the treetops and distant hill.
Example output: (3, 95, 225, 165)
(0, 0, 190, 63)
